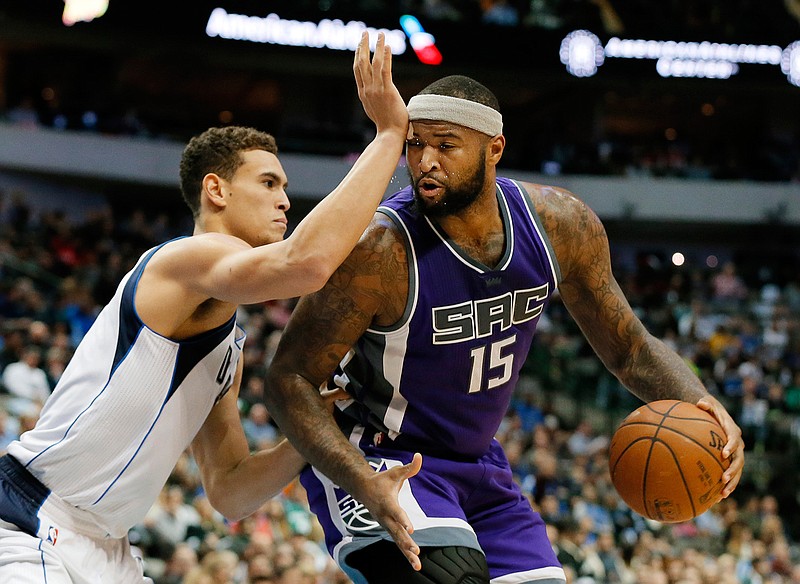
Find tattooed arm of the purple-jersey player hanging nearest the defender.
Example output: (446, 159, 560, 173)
(265, 213, 422, 570)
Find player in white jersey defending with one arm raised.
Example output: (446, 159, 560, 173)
(0, 35, 420, 584)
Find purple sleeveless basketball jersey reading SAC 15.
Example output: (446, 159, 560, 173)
(336, 178, 559, 459)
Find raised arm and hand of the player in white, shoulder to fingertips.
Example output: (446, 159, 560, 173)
(148, 33, 408, 307)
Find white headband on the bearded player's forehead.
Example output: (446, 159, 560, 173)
(408, 93, 503, 136)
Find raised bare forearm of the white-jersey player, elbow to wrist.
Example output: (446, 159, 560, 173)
(288, 133, 405, 286)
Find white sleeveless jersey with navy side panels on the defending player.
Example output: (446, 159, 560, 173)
(8, 244, 245, 537)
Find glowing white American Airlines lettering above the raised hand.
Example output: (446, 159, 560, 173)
(206, 8, 406, 55)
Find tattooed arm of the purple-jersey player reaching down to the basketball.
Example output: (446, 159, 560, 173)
(525, 183, 744, 497)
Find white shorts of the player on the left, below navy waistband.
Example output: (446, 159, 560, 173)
(0, 521, 152, 584)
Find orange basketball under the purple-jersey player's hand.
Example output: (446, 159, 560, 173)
(609, 400, 730, 523)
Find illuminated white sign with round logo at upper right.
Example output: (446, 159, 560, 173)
(559, 30, 800, 86)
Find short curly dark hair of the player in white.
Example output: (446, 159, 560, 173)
(180, 126, 278, 217)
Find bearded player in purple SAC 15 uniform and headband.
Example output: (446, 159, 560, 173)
(268, 76, 744, 584)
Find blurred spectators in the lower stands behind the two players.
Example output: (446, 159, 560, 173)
(0, 188, 800, 584)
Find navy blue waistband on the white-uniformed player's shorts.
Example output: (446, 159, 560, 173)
(0, 455, 50, 536)
